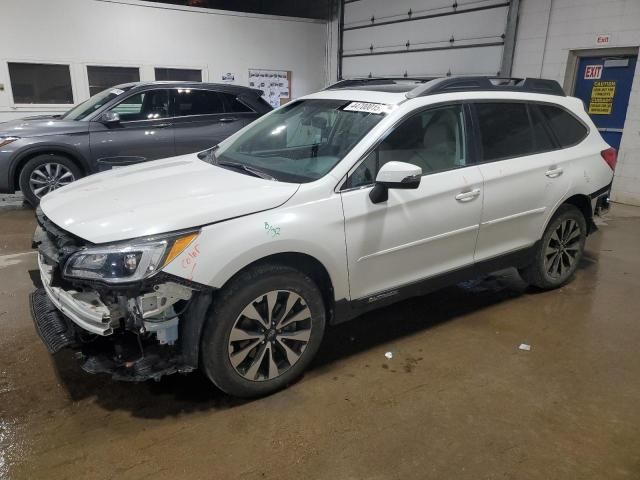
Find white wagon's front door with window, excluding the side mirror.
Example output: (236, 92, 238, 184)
(341, 105, 482, 300)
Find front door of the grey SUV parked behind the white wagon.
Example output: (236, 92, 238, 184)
(89, 89, 175, 170)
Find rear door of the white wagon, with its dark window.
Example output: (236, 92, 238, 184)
(473, 101, 572, 261)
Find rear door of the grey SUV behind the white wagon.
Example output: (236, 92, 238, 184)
(172, 88, 248, 155)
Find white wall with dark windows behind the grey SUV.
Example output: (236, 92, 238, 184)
(0, 0, 327, 121)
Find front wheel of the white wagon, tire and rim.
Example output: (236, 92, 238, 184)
(200, 265, 326, 397)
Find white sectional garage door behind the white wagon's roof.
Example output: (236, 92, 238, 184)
(342, 0, 510, 78)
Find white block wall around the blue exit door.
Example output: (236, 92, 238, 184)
(513, 0, 640, 205)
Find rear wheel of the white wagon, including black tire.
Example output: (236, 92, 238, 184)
(520, 205, 587, 290)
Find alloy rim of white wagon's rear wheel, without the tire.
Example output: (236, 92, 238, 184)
(544, 219, 582, 279)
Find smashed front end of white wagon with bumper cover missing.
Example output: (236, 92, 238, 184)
(30, 214, 211, 381)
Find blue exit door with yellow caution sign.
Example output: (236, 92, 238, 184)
(575, 56, 637, 150)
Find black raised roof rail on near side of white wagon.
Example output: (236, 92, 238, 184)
(406, 76, 566, 98)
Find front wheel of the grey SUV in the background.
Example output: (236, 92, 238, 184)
(18, 153, 82, 207)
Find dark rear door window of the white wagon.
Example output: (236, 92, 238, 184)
(475, 103, 536, 161)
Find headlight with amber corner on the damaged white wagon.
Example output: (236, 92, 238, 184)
(63, 232, 198, 283)
